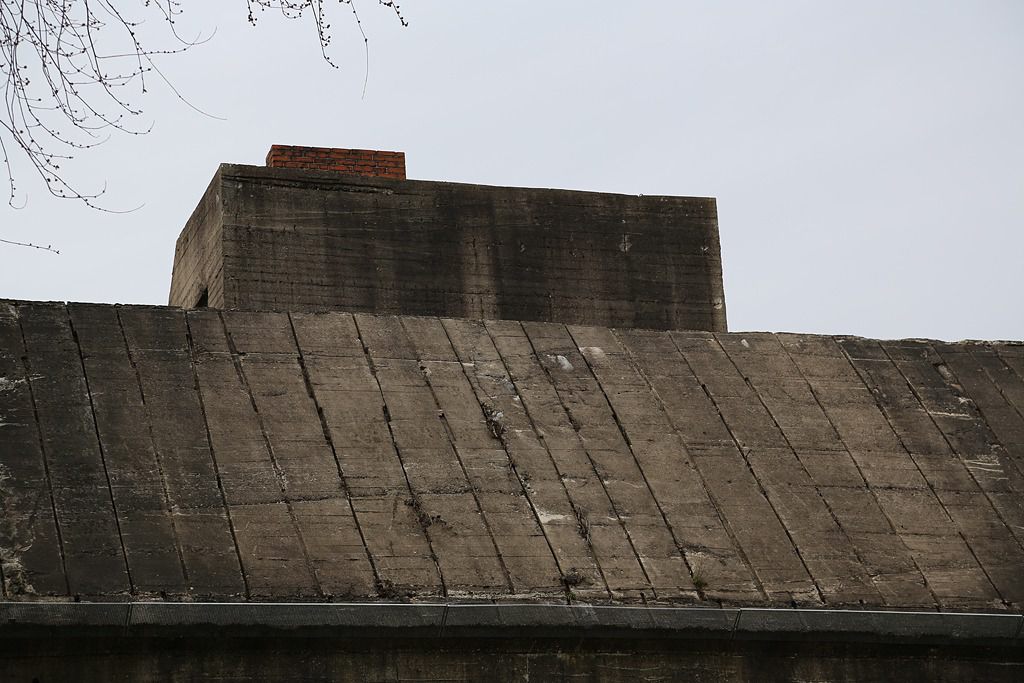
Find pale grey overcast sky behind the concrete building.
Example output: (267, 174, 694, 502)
(0, 0, 1024, 339)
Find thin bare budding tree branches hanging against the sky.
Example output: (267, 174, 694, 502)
(0, 0, 407, 211)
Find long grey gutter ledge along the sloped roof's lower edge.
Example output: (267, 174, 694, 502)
(0, 602, 1024, 647)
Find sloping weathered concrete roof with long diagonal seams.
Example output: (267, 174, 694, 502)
(0, 302, 1024, 611)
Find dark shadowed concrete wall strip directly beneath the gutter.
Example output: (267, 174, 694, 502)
(0, 638, 1024, 683)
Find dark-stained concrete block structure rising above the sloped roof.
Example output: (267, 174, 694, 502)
(170, 165, 726, 332)
